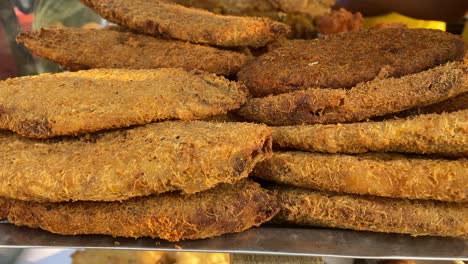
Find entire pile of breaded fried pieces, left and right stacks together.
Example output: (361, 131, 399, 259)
(0, 0, 468, 241)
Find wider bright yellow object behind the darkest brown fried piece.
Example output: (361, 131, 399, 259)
(364, 13, 446, 31)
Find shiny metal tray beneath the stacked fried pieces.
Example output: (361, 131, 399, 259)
(0, 223, 468, 260)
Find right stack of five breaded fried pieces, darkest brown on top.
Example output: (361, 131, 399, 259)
(239, 28, 468, 237)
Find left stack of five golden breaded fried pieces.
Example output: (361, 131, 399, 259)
(0, 0, 296, 241)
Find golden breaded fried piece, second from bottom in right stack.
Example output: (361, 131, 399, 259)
(251, 151, 468, 202)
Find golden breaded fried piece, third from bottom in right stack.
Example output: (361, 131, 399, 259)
(273, 110, 468, 157)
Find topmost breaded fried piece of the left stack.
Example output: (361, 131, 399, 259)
(81, 0, 289, 47)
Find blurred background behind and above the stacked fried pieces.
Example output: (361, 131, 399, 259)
(0, 0, 468, 80)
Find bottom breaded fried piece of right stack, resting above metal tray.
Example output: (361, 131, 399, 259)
(272, 186, 468, 237)
